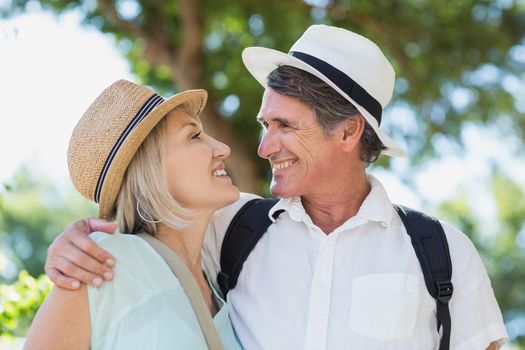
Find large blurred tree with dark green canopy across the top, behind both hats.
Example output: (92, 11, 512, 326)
(0, 0, 525, 192)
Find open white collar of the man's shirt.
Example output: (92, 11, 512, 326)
(268, 175, 394, 229)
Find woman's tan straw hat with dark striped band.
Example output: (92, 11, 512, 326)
(67, 80, 207, 218)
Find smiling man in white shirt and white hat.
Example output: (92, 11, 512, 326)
(46, 25, 506, 350)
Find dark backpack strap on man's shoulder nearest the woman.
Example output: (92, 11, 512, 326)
(217, 198, 282, 299)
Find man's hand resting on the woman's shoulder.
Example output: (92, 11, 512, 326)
(45, 218, 117, 289)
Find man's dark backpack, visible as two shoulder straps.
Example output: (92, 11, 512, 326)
(217, 198, 454, 350)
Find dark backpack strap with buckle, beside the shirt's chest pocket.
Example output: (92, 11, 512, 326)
(394, 205, 454, 350)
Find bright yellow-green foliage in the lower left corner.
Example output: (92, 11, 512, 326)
(0, 270, 52, 338)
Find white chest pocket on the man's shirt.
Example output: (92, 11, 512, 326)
(350, 273, 421, 340)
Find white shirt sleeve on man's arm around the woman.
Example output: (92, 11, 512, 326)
(202, 192, 261, 292)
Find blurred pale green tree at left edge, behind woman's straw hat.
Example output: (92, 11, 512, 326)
(0, 167, 96, 283)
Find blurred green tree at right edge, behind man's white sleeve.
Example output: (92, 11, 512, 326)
(438, 172, 525, 349)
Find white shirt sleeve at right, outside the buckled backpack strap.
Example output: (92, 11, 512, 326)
(443, 224, 508, 350)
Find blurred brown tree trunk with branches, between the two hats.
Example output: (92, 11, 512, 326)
(98, 0, 262, 193)
